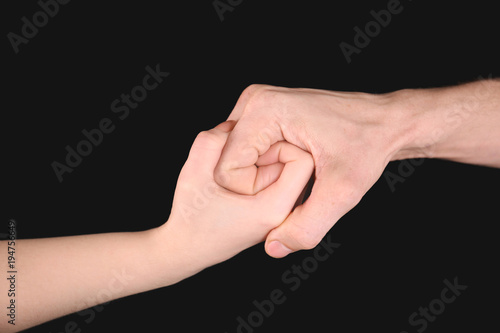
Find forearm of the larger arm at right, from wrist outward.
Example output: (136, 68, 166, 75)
(393, 80, 500, 167)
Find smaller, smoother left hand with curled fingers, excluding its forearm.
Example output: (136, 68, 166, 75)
(162, 121, 314, 268)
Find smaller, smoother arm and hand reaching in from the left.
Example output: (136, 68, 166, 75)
(0, 121, 314, 332)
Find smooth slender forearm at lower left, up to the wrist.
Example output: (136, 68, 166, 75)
(0, 224, 199, 332)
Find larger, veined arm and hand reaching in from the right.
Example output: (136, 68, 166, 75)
(214, 80, 500, 258)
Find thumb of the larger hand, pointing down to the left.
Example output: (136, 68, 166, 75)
(265, 167, 362, 258)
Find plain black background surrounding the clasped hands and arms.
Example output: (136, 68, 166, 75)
(0, 0, 500, 333)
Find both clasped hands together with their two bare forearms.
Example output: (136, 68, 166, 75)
(0, 80, 500, 332)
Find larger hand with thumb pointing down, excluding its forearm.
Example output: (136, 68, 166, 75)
(214, 85, 412, 257)
